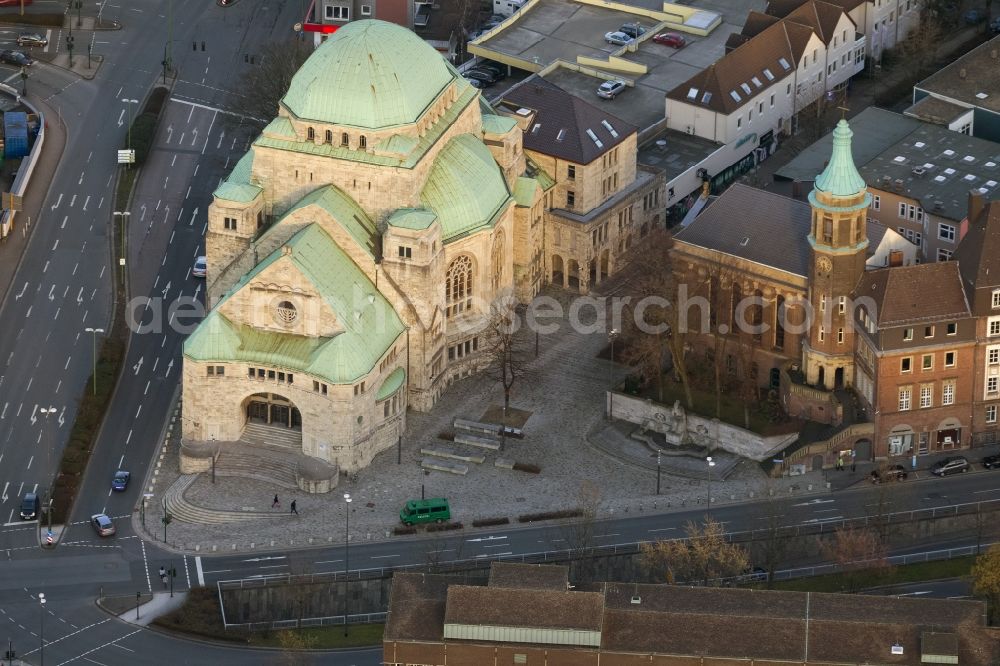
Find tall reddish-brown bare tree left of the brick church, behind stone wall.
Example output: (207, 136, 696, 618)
(623, 229, 694, 409)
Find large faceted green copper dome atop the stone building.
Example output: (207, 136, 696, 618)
(281, 20, 455, 129)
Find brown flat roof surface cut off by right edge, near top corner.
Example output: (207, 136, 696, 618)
(914, 36, 1000, 113)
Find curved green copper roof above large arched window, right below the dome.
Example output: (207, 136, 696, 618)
(420, 134, 510, 242)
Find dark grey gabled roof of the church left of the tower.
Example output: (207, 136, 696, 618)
(674, 183, 811, 277)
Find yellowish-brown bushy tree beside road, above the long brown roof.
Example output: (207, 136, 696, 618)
(641, 518, 750, 585)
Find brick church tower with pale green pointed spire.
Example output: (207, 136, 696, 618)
(802, 119, 872, 389)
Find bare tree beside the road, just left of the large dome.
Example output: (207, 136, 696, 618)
(225, 37, 313, 129)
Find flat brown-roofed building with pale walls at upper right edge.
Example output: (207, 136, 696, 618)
(904, 36, 1000, 142)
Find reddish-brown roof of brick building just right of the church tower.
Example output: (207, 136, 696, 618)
(854, 261, 971, 328)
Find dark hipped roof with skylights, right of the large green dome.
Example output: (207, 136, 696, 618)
(500, 76, 638, 164)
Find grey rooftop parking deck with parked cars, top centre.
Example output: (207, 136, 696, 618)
(470, 0, 767, 131)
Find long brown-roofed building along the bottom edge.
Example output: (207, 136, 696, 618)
(382, 563, 1000, 666)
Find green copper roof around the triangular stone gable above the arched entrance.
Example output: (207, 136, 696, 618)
(184, 224, 405, 384)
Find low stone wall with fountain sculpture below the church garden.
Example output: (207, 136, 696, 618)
(608, 393, 798, 461)
